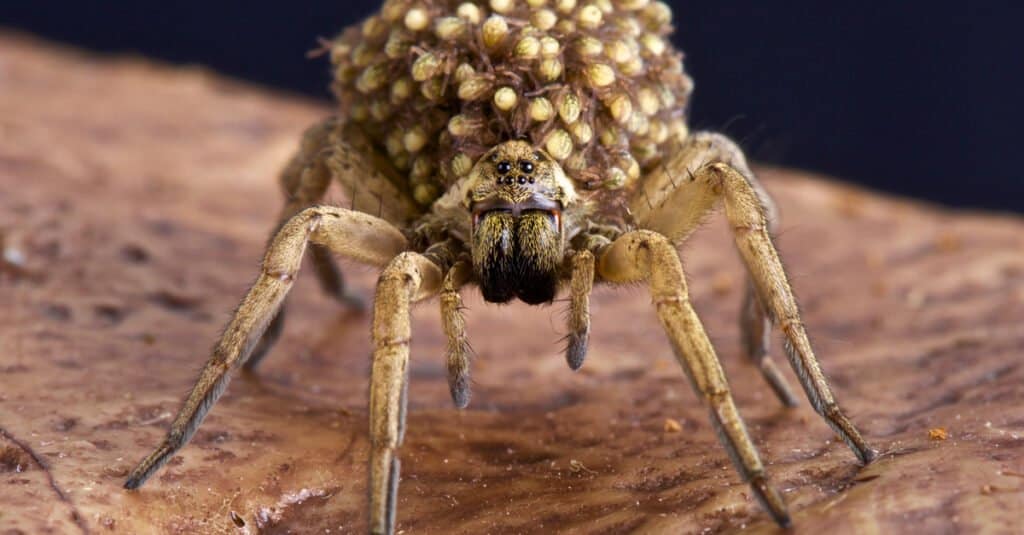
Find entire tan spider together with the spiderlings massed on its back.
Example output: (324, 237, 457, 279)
(117, 0, 876, 533)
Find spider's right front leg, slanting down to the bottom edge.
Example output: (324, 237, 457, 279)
(598, 231, 790, 527)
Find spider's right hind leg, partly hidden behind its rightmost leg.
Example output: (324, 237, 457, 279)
(630, 132, 799, 407)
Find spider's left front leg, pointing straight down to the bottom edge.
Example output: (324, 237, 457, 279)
(370, 252, 442, 534)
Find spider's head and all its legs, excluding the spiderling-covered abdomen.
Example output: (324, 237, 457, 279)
(125, 116, 876, 533)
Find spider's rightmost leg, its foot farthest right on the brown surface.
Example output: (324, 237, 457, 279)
(641, 134, 877, 463)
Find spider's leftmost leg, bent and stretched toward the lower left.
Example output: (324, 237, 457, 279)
(125, 206, 407, 489)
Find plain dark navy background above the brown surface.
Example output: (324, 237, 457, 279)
(0, 0, 1024, 211)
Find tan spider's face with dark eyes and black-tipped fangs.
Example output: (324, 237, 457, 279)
(466, 140, 575, 304)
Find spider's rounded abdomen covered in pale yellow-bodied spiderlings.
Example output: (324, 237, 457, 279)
(331, 0, 692, 206)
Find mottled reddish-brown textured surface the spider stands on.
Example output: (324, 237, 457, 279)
(0, 35, 1024, 533)
